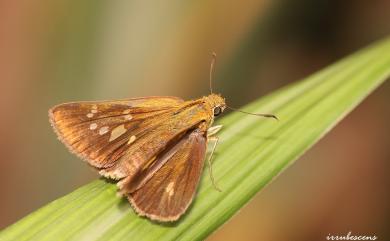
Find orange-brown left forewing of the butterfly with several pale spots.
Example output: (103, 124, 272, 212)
(49, 97, 183, 169)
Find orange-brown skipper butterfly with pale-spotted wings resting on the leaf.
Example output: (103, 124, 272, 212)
(49, 55, 276, 222)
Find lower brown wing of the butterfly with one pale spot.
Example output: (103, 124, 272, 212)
(128, 129, 206, 221)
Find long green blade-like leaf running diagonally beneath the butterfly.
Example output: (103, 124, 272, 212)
(0, 36, 390, 240)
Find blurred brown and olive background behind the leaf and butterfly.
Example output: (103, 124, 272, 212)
(0, 0, 390, 241)
